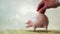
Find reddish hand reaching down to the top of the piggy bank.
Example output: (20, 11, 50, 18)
(37, 0, 59, 14)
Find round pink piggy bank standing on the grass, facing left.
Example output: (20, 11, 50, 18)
(26, 14, 49, 31)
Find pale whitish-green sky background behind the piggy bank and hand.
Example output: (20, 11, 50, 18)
(0, 0, 60, 29)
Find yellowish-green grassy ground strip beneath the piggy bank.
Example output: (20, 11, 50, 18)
(0, 29, 60, 34)
